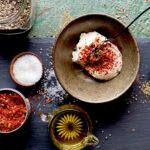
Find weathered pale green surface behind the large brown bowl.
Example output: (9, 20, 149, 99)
(30, 0, 150, 37)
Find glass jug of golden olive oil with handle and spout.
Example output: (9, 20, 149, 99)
(47, 104, 99, 150)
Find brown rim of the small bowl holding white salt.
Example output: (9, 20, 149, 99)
(9, 52, 44, 87)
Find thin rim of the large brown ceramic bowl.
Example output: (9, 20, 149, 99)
(52, 13, 140, 104)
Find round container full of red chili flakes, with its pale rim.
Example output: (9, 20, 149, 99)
(0, 88, 30, 134)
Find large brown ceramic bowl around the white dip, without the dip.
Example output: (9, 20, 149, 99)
(53, 14, 140, 103)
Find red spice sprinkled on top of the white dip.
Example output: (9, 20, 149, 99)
(81, 43, 117, 74)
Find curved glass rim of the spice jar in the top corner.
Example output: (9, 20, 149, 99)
(0, 0, 27, 24)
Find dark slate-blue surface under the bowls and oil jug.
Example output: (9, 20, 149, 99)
(0, 38, 150, 150)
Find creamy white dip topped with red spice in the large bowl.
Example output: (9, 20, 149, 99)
(72, 31, 122, 80)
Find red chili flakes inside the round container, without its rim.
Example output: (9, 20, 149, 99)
(0, 92, 26, 132)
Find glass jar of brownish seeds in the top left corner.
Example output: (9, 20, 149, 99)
(0, 0, 35, 35)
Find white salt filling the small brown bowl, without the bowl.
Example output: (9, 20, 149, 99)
(13, 54, 43, 86)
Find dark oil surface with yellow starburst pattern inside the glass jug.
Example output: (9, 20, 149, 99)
(54, 110, 88, 144)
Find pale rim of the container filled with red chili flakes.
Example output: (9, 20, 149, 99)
(0, 88, 31, 134)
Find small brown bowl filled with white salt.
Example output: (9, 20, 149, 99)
(10, 52, 43, 87)
